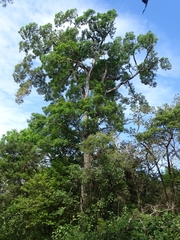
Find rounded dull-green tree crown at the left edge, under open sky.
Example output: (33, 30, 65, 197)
(0, 130, 45, 198)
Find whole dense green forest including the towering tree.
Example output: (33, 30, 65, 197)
(0, 9, 180, 240)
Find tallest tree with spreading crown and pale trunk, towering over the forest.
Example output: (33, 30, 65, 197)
(13, 9, 171, 210)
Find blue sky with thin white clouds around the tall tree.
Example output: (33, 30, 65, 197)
(0, 0, 180, 136)
